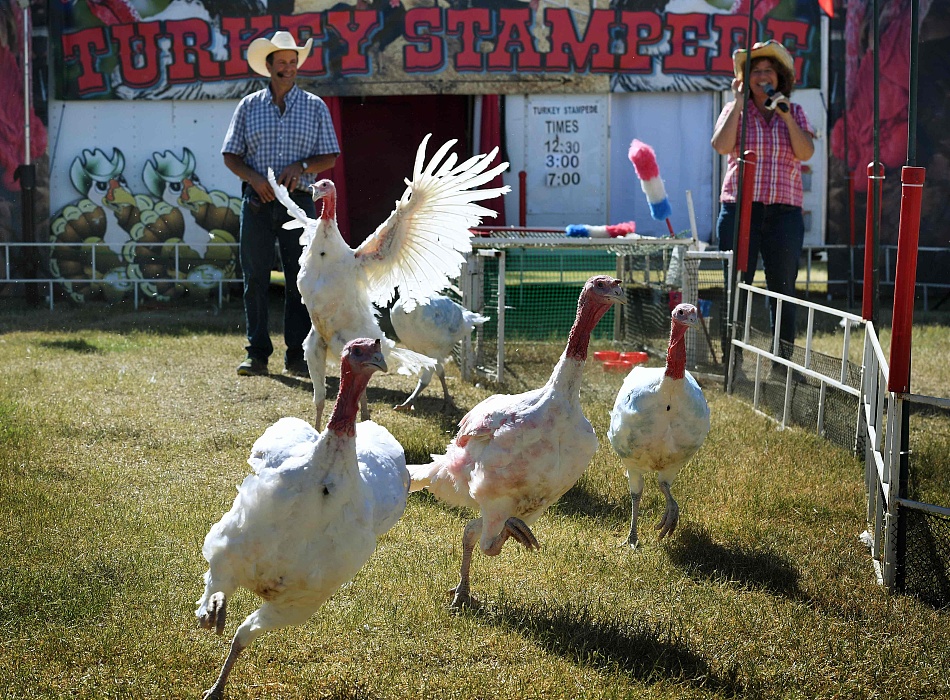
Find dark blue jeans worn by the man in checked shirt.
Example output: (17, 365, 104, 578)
(241, 187, 316, 362)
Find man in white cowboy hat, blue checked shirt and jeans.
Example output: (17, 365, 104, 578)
(221, 31, 340, 376)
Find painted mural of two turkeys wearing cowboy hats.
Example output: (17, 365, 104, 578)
(50, 148, 240, 302)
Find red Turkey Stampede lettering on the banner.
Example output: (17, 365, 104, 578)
(61, 6, 819, 99)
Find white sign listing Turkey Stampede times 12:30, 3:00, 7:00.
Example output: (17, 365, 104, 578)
(525, 95, 608, 219)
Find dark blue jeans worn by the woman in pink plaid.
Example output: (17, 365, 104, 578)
(716, 202, 805, 354)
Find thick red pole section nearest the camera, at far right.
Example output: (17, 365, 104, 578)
(887, 165, 927, 394)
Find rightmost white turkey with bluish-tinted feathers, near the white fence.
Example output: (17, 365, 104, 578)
(607, 304, 709, 548)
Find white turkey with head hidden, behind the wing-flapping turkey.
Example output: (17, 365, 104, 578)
(389, 294, 488, 411)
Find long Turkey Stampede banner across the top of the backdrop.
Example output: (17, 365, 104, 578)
(51, 0, 820, 100)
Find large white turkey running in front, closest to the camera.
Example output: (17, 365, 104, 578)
(196, 338, 409, 700)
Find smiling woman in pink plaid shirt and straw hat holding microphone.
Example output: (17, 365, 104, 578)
(712, 40, 815, 356)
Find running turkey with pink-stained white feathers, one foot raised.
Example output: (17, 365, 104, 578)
(409, 276, 624, 608)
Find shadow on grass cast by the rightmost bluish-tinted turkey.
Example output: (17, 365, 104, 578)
(668, 525, 802, 598)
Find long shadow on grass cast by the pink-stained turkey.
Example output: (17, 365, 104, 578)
(488, 601, 748, 697)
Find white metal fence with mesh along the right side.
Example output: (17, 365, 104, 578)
(727, 284, 950, 606)
